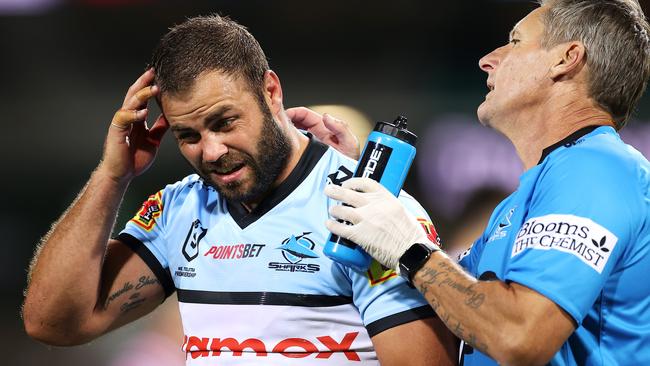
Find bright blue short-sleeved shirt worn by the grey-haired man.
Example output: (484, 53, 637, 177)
(460, 126, 650, 365)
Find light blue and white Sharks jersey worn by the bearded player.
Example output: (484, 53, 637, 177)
(118, 139, 434, 365)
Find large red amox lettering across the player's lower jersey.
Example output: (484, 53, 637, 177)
(183, 332, 361, 361)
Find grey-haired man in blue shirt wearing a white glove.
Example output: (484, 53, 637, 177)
(314, 0, 650, 365)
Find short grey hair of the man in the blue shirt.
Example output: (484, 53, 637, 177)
(538, 0, 650, 129)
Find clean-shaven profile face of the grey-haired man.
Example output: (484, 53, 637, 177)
(477, 7, 551, 129)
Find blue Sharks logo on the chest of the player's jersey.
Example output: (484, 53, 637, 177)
(269, 231, 320, 273)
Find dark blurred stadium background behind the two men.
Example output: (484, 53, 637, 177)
(0, 0, 650, 366)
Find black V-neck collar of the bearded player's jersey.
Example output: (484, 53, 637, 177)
(227, 134, 328, 229)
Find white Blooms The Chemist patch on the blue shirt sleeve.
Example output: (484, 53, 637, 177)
(512, 215, 618, 273)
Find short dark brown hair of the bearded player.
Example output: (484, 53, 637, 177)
(151, 14, 269, 100)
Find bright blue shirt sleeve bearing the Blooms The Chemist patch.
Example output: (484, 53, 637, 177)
(505, 148, 642, 324)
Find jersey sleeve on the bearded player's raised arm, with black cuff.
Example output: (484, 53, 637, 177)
(115, 186, 175, 296)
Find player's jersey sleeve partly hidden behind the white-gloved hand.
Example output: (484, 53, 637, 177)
(346, 192, 435, 337)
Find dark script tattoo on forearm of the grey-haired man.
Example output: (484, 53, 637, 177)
(417, 263, 488, 353)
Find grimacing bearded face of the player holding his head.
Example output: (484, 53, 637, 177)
(162, 71, 291, 202)
